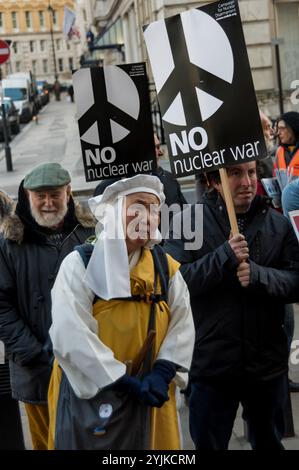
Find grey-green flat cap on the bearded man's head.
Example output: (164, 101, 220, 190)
(24, 163, 71, 191)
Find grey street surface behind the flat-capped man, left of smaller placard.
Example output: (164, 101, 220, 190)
(0, 94, 101, 198)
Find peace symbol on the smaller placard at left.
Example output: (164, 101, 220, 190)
(73, 65, 140, 147)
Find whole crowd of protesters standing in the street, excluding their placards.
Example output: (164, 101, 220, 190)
(0, 112, 299, 450)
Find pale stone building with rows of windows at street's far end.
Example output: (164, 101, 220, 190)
(0, 0, 91, 83)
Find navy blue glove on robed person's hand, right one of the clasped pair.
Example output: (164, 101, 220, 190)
(140, 360, 176, 408)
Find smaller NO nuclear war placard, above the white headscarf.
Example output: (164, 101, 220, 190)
(73, 63, 156, 181)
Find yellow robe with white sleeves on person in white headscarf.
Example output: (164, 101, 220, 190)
(49, 249, 194, 449)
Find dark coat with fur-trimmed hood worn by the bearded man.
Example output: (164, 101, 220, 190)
(0, 184, 94, 403)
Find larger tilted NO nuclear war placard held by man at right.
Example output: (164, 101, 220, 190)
(144, 0, 267, 177)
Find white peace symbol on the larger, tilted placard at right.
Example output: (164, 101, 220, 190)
(144, 9, 234, 127)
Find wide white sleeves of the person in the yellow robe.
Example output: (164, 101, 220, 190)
(50, 251, 195, 399)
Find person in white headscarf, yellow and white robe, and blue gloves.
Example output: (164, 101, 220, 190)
(49, 175, 194, 450)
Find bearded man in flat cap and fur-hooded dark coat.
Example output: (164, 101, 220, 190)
(0, 163, 94, 450)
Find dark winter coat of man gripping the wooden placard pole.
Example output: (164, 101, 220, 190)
(165, 192, 299, 380)
